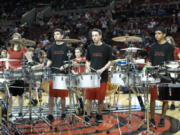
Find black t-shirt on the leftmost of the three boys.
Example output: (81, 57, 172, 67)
(47, 43, 69, 73)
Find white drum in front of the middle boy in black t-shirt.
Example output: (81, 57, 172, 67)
(76, 73, 101, 88)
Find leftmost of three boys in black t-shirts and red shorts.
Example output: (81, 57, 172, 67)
(47, 29, 69, 121)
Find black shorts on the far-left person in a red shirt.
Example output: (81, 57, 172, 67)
(9, 80, 27, 96)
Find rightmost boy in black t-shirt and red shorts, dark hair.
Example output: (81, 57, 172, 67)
(148, 26, 173, 127)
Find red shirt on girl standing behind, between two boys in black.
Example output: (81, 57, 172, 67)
(73, 58, 86, 74)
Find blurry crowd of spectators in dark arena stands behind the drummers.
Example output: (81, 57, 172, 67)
(0, 0, 180, 56)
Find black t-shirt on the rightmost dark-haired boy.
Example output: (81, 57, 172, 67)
(149, 42, 174, 66)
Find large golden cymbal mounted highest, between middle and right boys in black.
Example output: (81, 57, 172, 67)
(112, 36, 142, 42)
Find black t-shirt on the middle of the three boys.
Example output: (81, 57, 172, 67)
(86, 43, 112, 82)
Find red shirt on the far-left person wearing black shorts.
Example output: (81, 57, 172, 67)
(8, 48, 27, 69)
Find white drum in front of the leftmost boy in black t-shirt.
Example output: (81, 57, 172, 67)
(53, 74, 76, 90)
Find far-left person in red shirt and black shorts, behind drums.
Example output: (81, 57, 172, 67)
(6, 33, 30, 116)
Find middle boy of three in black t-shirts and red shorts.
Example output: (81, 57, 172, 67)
(85, 28, 112, 122)
